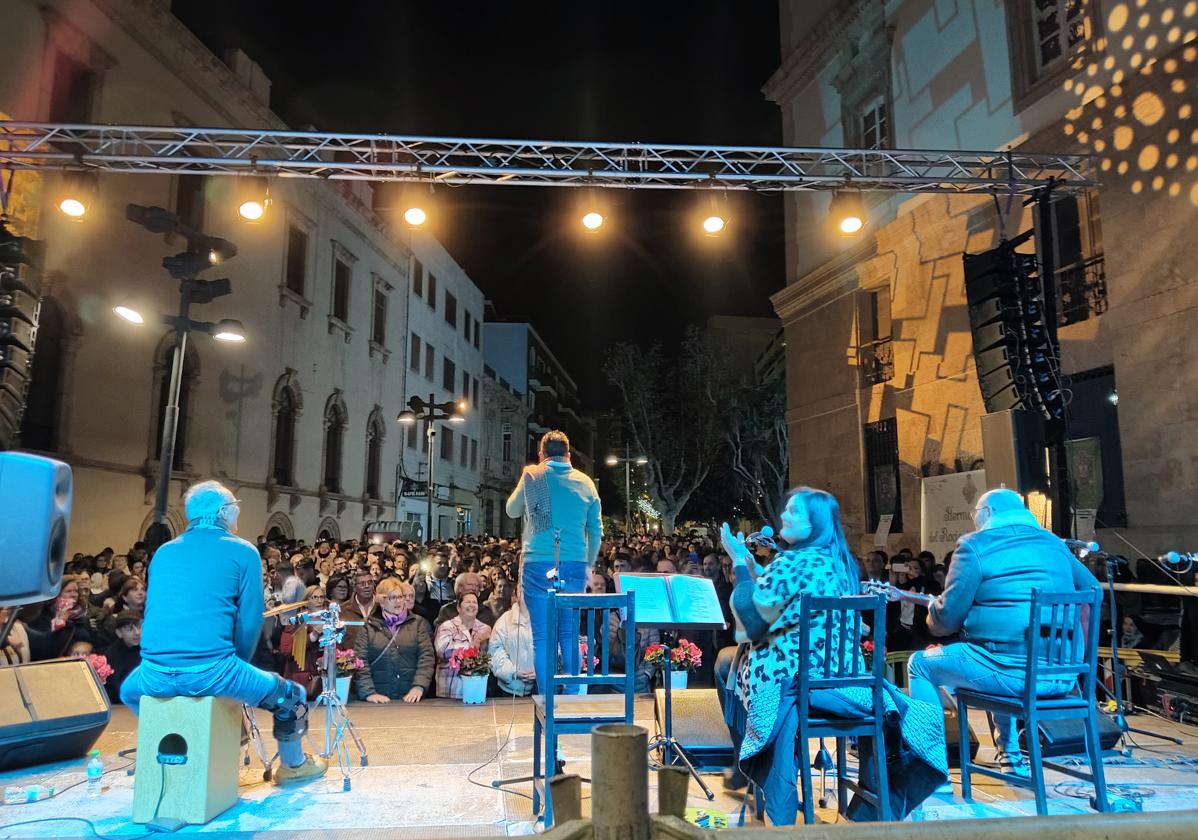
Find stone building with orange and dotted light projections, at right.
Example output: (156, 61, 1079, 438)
(766, 0, 1198, 555)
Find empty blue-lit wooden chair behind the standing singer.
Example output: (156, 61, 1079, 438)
(532, 592, 636, 828)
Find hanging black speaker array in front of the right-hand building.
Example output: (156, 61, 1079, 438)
(964, 237, 1065, 421)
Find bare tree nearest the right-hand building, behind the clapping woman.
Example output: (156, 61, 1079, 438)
(724, 380, 789, 522)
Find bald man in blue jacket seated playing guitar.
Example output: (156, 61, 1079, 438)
(908, 490, 1099, 778)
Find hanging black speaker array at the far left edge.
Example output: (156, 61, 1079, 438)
(0, 223, 43, 449)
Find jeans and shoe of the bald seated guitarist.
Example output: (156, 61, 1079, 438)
(907, 642, 1073, 755)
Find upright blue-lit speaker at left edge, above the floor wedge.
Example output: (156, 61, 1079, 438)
(0, 452, 71, 606)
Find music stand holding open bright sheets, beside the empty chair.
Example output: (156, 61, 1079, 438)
(616, 573, 727, 800)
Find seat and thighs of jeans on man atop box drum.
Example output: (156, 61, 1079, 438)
(121, 655, 278, 714)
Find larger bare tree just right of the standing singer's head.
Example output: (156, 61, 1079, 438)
(604, 326, 728, 533)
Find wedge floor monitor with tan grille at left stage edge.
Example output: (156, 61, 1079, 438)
(0, 659, 111, 770)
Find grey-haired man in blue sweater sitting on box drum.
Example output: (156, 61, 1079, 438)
(121, 482, 327, 784)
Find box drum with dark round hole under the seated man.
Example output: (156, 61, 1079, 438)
(133, 697, 242, 826)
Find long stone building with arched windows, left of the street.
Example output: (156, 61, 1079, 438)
(0, 0, 482, 551)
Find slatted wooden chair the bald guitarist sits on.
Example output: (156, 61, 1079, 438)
(956, 590, 1111, 816)
